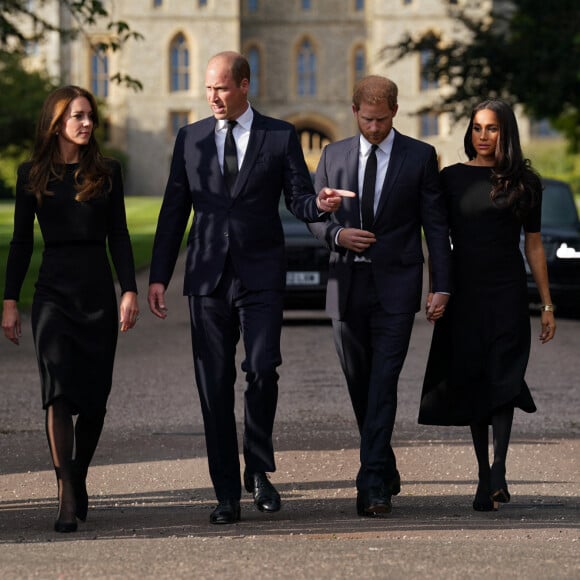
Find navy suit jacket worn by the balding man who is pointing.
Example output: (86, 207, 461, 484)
(149, 110, 319, 295)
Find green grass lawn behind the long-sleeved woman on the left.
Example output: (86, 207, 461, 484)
(0, 197, 168, 310)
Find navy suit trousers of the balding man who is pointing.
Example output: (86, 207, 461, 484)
(189, 259, 284, 501)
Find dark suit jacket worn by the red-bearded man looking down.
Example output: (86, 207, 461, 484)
(308, 129, 450, 319)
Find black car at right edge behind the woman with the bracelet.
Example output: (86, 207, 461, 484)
(521, 179, 580, 313)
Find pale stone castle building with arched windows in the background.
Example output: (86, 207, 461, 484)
(19, 0, 536, 195)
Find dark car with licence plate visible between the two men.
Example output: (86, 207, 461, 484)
(280, 196, 329, 310)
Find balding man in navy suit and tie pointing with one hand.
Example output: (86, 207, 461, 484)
(148, 52, 348, 524)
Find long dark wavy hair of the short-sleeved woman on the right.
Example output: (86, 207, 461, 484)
(463, 99, 542, 218)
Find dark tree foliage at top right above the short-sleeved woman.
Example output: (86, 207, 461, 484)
(383, 0, 580, 151)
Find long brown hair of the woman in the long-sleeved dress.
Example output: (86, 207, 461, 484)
(28, 85, 111, 204)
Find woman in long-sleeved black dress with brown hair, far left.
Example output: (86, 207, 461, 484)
(2, 86, 139, 532)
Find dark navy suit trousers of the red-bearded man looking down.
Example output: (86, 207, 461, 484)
(332, 262, 415, 491)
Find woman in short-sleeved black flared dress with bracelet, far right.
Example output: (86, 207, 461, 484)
(419, 100, 556, 511)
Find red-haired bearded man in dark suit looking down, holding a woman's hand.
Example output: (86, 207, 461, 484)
(308, 76, 450, 517)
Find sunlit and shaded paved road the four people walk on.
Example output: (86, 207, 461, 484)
(0, 255, 580, 580)
